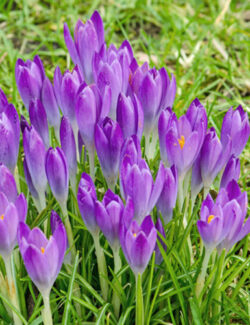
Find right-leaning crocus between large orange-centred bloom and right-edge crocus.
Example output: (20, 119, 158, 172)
(191, 128, 232, 198)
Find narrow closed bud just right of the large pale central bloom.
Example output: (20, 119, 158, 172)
(156, 166, 178, 223)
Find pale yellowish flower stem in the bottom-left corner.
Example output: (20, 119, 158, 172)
(4, 255, 22, 325)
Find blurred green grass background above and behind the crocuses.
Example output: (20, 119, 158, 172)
(0, 0, 250, 182)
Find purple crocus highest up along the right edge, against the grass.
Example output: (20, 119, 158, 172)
(221, 105, 250, 157)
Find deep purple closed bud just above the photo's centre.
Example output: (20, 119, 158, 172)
(116, 93, 143, 139)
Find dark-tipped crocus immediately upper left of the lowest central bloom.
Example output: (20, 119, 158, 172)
(95, 189, 124, 251)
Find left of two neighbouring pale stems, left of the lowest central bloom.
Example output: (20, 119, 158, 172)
(93, 233, 108, 300)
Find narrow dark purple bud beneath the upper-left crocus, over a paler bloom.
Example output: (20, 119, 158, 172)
(29, 99, 49, 148)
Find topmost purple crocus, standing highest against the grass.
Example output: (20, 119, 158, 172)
(64, 11, 104, 83)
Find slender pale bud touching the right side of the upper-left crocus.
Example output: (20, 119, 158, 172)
(42, 77, 60, 131)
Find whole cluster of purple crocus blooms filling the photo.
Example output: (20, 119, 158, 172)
(0, 12, 250, 322)
